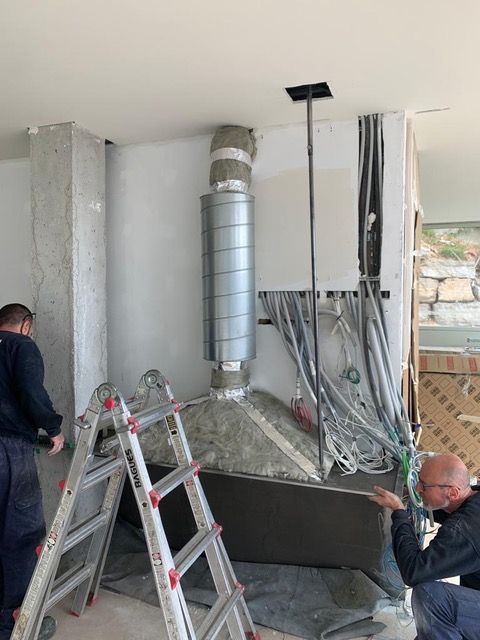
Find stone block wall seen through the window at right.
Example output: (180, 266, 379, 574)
(419, 228, 480, 327)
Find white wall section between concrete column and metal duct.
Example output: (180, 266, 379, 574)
(106, 136, 211, 399)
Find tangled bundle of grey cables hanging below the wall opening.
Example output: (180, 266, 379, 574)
(260, 291, 401, 474)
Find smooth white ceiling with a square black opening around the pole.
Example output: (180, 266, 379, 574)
(0, 0, 480, 219)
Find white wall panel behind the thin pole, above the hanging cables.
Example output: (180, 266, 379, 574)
(252, 120, 358, 291)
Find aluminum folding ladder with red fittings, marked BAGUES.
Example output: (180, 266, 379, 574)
(11, 370, 260, 640)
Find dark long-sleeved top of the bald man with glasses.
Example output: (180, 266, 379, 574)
(392, 491, 480, 590)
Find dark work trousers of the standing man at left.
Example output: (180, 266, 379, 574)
(0, 435, 45, 640)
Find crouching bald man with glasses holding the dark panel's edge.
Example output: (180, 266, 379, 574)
(369, 455, 480, 640)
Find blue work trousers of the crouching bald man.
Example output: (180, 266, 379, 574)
(412, 580, 480, 640)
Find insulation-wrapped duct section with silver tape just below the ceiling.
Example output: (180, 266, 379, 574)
(210, 126, 257, 193)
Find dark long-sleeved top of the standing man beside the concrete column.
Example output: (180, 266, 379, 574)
(0, 331, 62, 443)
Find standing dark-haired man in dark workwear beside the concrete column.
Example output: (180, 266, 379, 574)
(0, 303, 64, 640)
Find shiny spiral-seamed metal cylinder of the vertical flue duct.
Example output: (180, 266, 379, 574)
(200, 192, 256, 362)
